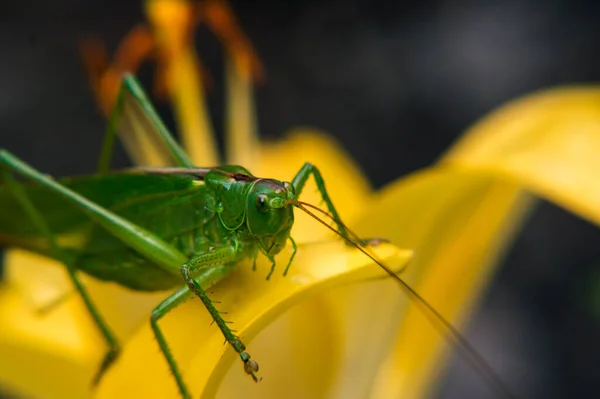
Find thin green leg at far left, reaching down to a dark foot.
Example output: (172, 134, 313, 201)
(0, 151, 120, 385)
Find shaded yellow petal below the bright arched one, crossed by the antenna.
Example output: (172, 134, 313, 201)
(354, 168, 530, 398)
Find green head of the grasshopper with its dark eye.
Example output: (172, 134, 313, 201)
(246, 179, 296, 255)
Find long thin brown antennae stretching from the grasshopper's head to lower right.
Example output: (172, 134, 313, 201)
(286, 200, 516, 398)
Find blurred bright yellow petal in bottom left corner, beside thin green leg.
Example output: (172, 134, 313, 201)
(0, 250, 103, 399)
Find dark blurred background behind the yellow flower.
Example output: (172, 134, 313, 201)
(0, 0, 600, 398)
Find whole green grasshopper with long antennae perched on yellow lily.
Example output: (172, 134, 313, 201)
(0, 75, 510, 398)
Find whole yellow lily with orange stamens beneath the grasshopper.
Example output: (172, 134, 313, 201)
(0, 0, 600, 398)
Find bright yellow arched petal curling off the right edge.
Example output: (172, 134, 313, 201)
(441, 86, 600, 224)
